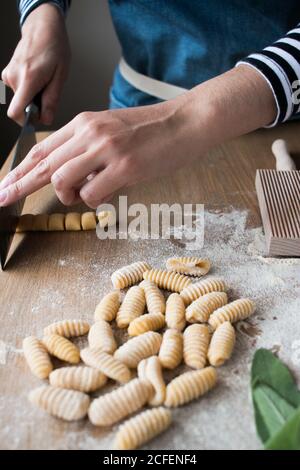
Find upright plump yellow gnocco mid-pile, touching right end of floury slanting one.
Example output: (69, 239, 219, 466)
(158, 329, 183, 369)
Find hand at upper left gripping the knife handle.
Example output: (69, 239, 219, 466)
(2, 4, 71, 125)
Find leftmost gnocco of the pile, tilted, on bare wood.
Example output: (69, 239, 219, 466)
(23, 336, 53, 379)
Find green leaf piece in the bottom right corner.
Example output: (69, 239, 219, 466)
(265, 408, 300, 450)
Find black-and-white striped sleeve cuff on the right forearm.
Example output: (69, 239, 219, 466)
(236, 23, 300, 127)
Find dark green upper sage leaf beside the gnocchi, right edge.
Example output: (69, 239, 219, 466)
(251, 349, 300, 407)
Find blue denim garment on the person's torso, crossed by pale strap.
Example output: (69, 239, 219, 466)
(109, 0, 300, 108)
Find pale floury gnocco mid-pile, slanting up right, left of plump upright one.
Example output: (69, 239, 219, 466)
(114, 331, 162, 369)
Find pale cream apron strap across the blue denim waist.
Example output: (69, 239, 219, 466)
(119, 57, 187, 101)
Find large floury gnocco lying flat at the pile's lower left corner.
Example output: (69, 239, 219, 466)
(29, 385, 90, 421)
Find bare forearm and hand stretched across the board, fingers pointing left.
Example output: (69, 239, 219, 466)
(0, 23, 298, 208)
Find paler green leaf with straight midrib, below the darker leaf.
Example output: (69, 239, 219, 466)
(253, 385, 295, 436)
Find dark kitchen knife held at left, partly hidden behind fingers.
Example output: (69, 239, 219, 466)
(0, 93, 41, 270)
